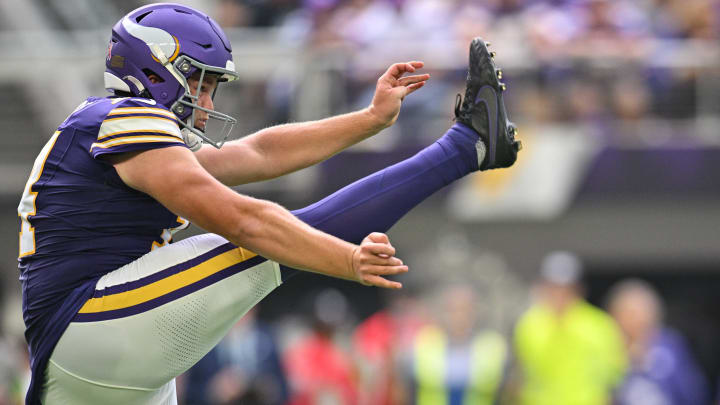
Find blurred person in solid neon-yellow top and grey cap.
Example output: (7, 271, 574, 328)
(513, 252, 627, 405)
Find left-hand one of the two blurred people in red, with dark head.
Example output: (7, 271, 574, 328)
(284, 290, 358, 405)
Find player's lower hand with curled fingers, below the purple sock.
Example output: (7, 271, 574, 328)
(352, 232, 408, 288)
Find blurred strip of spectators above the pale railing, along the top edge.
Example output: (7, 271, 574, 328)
(212, 0, 719, 42)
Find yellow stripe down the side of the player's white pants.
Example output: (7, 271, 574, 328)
(79, 248, 257, 313)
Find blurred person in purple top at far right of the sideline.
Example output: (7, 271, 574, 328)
(607, 279, 710, 405)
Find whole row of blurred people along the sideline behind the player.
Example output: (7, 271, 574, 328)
(173, 252, 711, 405)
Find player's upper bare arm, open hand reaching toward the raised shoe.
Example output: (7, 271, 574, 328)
(196, 62, 430, 185)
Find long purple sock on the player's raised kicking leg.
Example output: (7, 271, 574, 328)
(283, 123, 478, 278)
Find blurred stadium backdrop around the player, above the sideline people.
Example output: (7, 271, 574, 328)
(0, 0, 720, 404)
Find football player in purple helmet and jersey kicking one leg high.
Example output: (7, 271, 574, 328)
(18, 4, 519, 404)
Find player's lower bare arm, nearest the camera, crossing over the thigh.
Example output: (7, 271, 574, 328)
(111, 147, 407, 288)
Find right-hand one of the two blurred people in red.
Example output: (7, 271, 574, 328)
(353, 291, 427, 405)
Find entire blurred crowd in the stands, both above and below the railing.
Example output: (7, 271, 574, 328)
(211, 0, 720, 144)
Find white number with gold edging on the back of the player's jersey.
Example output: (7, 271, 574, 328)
(18, 131, 60, 257)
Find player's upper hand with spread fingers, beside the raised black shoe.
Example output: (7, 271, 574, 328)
(369, 61, 430, 127)
